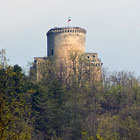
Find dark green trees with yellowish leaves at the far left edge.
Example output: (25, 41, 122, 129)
(0, 50, 32, 140)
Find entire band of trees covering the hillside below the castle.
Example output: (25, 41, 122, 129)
(0, 50, 140, 140)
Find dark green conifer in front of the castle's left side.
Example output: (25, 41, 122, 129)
(32, 77, 66, 139)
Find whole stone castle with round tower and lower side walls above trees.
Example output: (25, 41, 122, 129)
(30, 27, 102, 81)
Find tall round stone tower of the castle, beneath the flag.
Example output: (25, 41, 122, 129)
(46, 27, 86, 59)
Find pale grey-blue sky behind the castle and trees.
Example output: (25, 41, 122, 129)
(0, 0, 140, 76)
